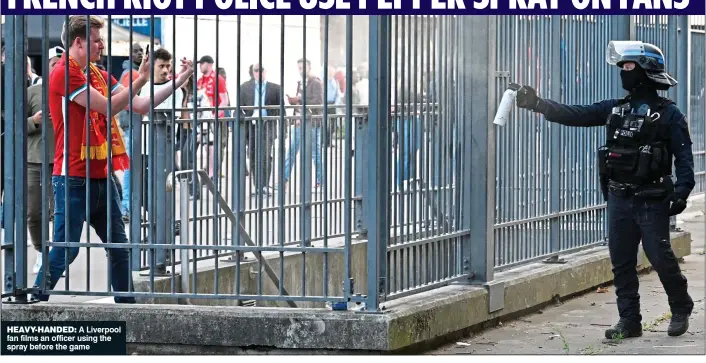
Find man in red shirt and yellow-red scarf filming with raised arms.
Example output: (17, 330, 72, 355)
(34, 16, 191, 303)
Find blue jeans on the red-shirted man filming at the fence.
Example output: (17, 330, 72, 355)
(34, 176, 135, 303)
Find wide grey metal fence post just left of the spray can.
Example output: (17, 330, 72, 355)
(463, 16, 497, 288)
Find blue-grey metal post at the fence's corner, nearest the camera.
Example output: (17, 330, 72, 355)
(363, 16, 390, 311)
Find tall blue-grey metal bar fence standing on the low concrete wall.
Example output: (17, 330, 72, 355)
(2, 16, 706, 310)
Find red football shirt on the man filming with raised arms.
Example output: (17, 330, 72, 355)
(49, 55, 120, 179)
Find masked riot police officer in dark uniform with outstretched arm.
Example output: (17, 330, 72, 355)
(516, 41, 695, 339)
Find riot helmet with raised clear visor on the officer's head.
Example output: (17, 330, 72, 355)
(606, 41, 677, 91)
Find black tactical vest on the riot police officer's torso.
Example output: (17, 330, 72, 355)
(598, 96, 674, 185)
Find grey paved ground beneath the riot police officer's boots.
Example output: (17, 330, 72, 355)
(429, 208, 706, 355)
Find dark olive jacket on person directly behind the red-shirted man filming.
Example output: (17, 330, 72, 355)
(27, 84, 54, 164)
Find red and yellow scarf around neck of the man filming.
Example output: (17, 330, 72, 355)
(69, 57, 130, 171)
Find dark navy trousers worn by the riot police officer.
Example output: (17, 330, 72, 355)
(608, 192, 694, 323)
